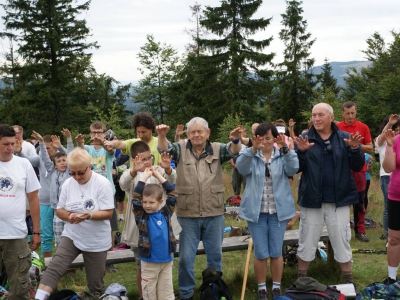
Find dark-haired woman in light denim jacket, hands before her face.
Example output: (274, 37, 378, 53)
(236, 123, 299, 300)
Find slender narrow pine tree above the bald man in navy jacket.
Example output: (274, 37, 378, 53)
(271, 0, 317, 123)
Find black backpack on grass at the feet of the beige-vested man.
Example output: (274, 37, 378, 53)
(200, 268, 233, 300)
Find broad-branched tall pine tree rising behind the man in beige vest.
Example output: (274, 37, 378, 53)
(198, 0, 274, 121)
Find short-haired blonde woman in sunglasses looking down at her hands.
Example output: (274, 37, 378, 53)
(35, 148, 114, 300)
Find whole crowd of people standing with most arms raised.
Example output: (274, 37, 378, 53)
(0, 102, 400, 300)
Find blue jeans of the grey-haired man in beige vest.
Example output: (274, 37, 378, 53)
(178, 216, 224, 299)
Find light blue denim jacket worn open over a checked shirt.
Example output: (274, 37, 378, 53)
(236, 147, 299, 223)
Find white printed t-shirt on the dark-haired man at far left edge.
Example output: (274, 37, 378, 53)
(0, 156, 40, 239)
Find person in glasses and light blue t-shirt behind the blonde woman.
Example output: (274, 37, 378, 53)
(75, 121, 118, 272)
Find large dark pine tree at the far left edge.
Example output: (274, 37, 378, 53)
(2, 0, 98, 130)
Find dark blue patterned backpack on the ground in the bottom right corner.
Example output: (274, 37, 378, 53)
(357, 281, 400, 300)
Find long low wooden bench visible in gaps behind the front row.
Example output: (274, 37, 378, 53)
(45, 227, 329, 268)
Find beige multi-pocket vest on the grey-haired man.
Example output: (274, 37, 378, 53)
(176, 142, 225, 218)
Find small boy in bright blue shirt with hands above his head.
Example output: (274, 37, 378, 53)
(132, 167, 177, 300)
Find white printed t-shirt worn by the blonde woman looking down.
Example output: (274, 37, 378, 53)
(57, 172, 114, 252)
